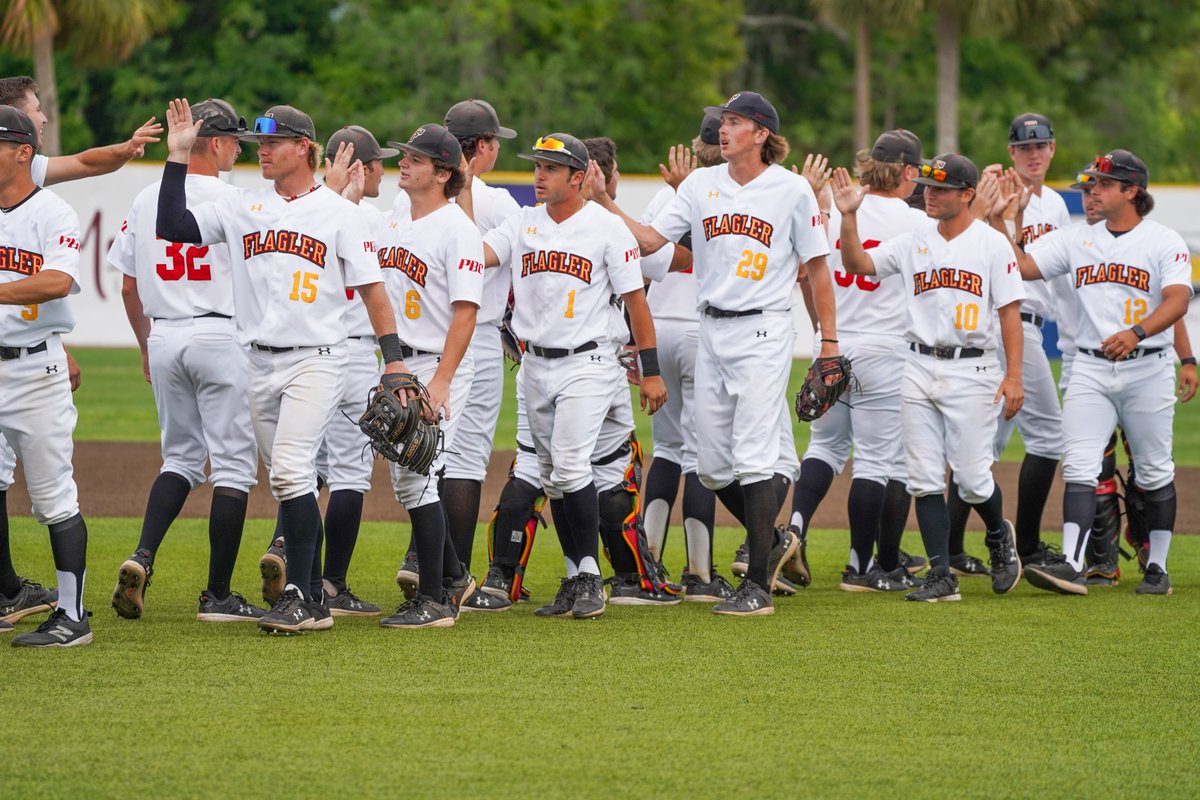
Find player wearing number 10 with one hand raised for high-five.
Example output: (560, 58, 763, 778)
(833, 154, 1022, 602)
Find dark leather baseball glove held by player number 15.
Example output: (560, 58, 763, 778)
(359, 373, 442, 475)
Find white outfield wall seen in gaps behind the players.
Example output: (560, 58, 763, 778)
(46, 163, 1200, 356)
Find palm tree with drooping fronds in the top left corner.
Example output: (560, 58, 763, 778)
(0, 0, 176, 155)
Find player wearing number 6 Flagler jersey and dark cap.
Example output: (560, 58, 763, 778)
(377, 124, 484, 628)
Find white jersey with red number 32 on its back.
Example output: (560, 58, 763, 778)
(108, 175, 238, 319)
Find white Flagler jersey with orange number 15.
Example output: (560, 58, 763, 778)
(188, 185, 383, 347)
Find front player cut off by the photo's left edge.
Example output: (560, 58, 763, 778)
(0, 106, 91, 648)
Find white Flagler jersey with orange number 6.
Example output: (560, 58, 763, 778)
(377, 203, 484, 353)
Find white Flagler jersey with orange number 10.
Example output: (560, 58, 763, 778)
(869, 219, 1025, 350)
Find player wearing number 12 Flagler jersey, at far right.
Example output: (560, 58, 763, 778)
(1016, 150, 1192, 595)
